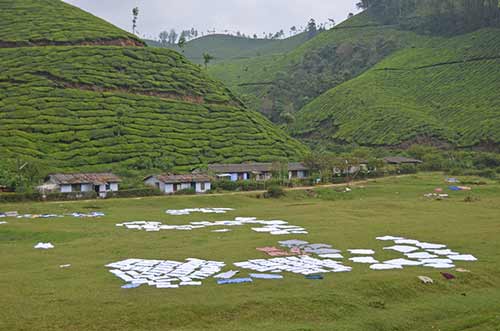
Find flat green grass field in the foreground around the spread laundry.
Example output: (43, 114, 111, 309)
(0, 174, 500, 331)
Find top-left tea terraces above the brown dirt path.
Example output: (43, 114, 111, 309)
(0, 0, 143, 43)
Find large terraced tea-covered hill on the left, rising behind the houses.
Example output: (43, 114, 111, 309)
(0, 0, 305, 175)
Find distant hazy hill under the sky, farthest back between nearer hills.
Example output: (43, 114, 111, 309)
(147, 33, 307, 63)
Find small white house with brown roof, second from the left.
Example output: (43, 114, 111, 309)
(144, 174, 212, 194)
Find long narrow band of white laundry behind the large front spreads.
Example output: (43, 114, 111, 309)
(116, 217, 307, 235)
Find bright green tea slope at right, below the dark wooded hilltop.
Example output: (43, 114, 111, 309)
(294, 29, 500, 146)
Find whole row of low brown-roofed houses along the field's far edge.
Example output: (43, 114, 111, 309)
(38, 157, 422, 198)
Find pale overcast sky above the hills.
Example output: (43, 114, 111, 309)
(65, 0, 357, 39)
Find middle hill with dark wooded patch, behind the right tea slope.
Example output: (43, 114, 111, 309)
(209, 13, 426, 123)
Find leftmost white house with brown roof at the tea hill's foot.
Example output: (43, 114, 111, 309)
(39, 173, 121, 198)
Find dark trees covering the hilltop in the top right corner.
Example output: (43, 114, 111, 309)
(357, 0, 500, 34)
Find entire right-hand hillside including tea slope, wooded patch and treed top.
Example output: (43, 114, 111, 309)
(206, 4, 500, 148)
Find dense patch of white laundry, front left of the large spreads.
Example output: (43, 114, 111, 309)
(106, 258, 225, 288)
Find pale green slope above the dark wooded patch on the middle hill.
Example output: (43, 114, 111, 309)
(209, 13, 425, 114)
